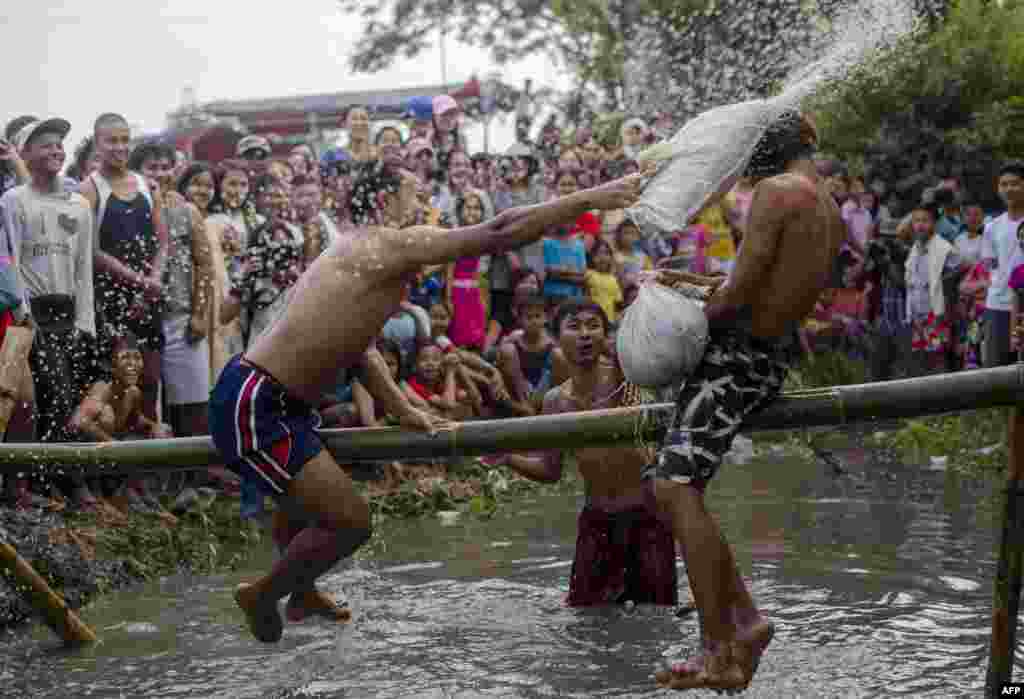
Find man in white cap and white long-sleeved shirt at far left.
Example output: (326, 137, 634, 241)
(0, 119, 96, 497)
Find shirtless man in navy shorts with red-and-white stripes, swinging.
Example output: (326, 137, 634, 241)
(210, 166, 640, 643)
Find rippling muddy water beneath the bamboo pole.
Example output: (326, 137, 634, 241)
(0, 446, 1007, 699)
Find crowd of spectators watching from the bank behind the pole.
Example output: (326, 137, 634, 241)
(0, 95, 1024, 513)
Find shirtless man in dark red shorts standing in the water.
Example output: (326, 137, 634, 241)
(490, 298, 679, 607)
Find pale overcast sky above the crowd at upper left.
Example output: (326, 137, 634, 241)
(0, 0, 568, 160)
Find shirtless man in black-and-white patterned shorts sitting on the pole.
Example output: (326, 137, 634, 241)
(645, 111, 846, 690)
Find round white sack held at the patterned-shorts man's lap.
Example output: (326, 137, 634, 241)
(615, 281, 708, 388)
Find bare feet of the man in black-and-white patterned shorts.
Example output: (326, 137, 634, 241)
(654, 621, 775, 693)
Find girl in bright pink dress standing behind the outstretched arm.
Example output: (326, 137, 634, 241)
(445, 190, 497, 352)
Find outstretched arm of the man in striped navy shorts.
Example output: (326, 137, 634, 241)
(386, 175, 643, 269)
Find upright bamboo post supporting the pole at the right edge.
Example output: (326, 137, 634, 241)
(985, 405, 1024, 697)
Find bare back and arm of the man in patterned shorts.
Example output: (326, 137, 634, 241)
(709, 172, 846, 338)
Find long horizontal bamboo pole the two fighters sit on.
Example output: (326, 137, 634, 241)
(0, 365, 1024, 475)
